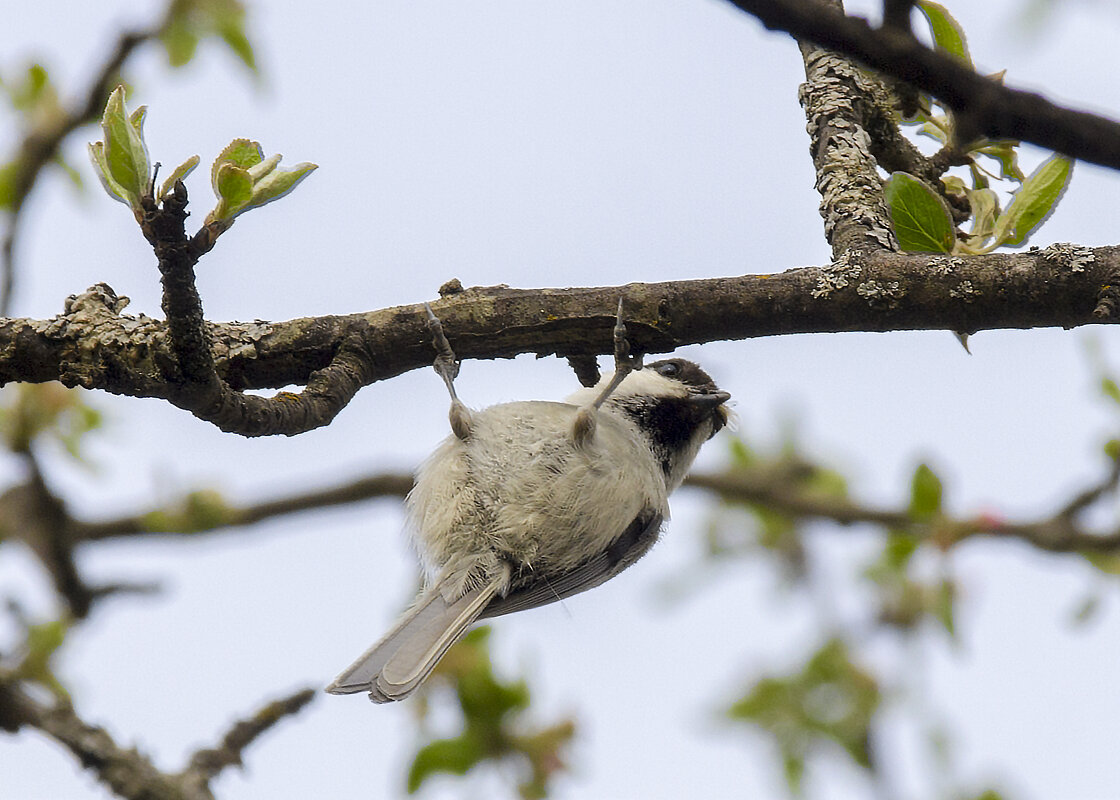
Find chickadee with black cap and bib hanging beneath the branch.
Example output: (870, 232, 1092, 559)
(327, 301, 730, 703)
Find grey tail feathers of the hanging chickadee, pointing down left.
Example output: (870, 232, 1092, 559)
(327, 576, 505, 703)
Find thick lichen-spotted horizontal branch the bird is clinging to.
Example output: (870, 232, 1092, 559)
(0, 245, 1120, 399)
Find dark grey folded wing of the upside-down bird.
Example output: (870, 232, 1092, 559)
(478, 509, 664, 620)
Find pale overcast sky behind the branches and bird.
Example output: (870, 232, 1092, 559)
(0, 0, 1120, 800)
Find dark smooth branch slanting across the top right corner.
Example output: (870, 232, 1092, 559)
(728, 0, 1120, 169)
